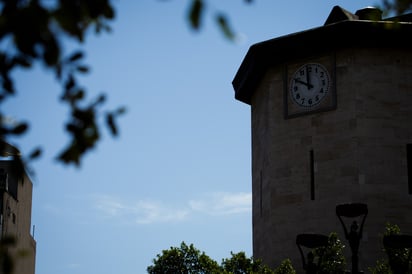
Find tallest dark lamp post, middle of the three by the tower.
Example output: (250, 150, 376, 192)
(336, 203, 368, 274)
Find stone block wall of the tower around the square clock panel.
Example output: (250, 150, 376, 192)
(251, 49, 412, 270)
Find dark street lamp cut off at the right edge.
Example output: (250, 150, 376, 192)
(383, 234, 412, 274)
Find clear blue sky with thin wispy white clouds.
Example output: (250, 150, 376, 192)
(4, 0, 375, 274)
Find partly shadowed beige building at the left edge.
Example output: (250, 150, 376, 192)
(0, 141, 36, 274)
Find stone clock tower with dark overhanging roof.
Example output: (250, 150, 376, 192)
(233, 6, 412, 270)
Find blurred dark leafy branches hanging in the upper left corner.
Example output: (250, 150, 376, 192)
(0, 0, 124, 165)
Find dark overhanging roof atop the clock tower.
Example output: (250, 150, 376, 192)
(232, 6, 412, 104)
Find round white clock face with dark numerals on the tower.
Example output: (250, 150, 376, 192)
(289, 63, 331, 108)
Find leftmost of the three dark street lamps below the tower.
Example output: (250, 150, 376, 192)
(296, 234, 329, 274)
